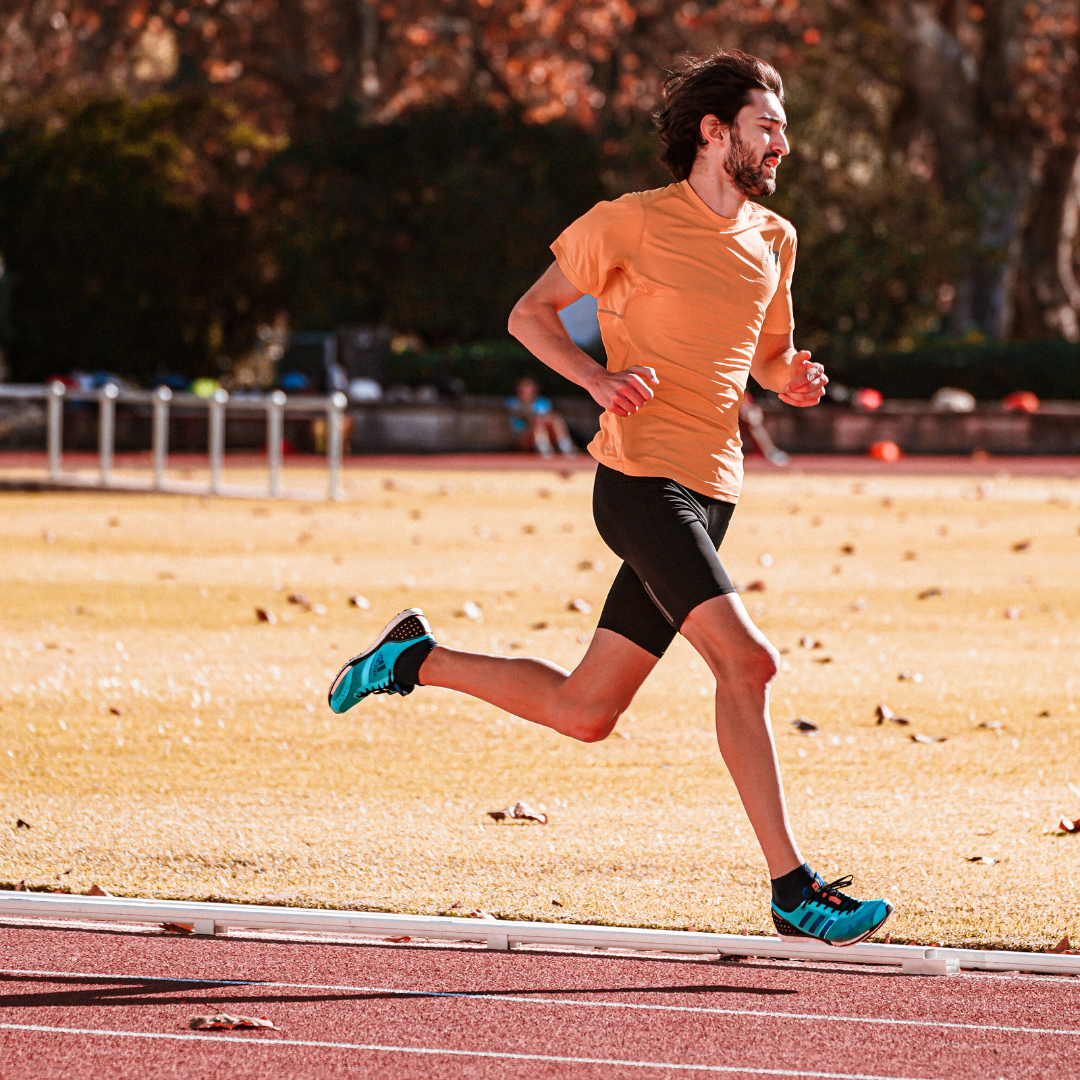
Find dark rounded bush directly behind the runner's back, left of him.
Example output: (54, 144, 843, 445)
(265, 106, 604, 348)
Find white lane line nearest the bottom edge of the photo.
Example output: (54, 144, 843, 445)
(0, 1024, 941, 1080)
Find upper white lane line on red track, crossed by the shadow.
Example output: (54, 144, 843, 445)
(0, 968, 1080, 1036)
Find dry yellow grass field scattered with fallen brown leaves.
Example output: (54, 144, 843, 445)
(0, 471, 1080, 948)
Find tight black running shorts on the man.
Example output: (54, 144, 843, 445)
(593, 464, 735, 657)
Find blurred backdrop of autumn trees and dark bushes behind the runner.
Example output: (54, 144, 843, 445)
(0, 0, 1080, 389)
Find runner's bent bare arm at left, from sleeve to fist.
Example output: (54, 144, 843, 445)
(508, 262, 658, 416)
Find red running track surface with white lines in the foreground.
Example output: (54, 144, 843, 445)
(0, 927, 1080, 1080)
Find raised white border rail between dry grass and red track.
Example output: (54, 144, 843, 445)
(0, 892, 1080, 975)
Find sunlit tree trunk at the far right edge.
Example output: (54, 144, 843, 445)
(1009, 146, 1080, 341)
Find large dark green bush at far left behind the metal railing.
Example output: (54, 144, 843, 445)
(0, 97, 278, 381)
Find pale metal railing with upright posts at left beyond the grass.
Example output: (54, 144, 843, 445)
(0, 381, 348, 500)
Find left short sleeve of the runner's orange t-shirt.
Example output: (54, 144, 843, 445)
(551, 193, 645, 296)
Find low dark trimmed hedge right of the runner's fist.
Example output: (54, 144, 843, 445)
(818, 340, 1080, 401)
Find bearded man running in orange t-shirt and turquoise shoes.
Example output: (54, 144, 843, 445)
(329, 52, 892, 945)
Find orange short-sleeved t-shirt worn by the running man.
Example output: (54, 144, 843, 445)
(551, 180, 795, 502)
